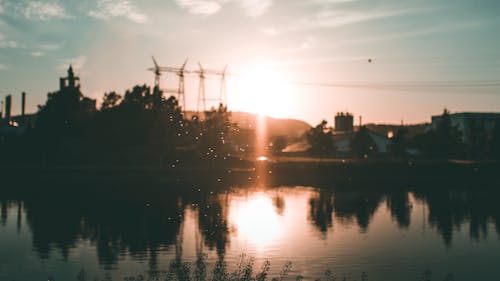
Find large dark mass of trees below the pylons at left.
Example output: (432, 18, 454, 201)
(2, 85, 240, 165)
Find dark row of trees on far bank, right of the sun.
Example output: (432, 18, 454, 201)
(306, 109, 500, 160)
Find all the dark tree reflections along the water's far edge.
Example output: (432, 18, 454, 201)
(0, 184, 500, 270)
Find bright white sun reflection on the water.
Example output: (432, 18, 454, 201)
(230, 194, 281, 248)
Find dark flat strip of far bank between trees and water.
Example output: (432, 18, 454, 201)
(0, 158, 500, 190)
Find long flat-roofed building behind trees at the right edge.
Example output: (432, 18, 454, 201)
(431, 112, 500, 144)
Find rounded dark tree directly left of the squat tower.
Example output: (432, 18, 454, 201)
(306, 120, 335, 160)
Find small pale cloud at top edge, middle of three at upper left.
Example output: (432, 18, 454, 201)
(88, 0, 149, 23)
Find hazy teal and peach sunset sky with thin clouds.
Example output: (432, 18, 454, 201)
(0, 0, 500, 125)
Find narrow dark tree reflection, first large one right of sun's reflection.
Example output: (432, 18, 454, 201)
(309, 189, 333, 235)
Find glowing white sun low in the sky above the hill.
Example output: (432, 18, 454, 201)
(230, 64, 296, 118)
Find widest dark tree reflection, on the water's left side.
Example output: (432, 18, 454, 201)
(24, 195, 182, 270)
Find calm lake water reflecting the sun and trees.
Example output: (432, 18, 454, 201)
(0, 182, 500, 281)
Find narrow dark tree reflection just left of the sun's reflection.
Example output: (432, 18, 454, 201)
(198, 194, 229, 257)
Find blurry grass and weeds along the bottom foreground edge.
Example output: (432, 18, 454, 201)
(72, 254, 455, 281)
